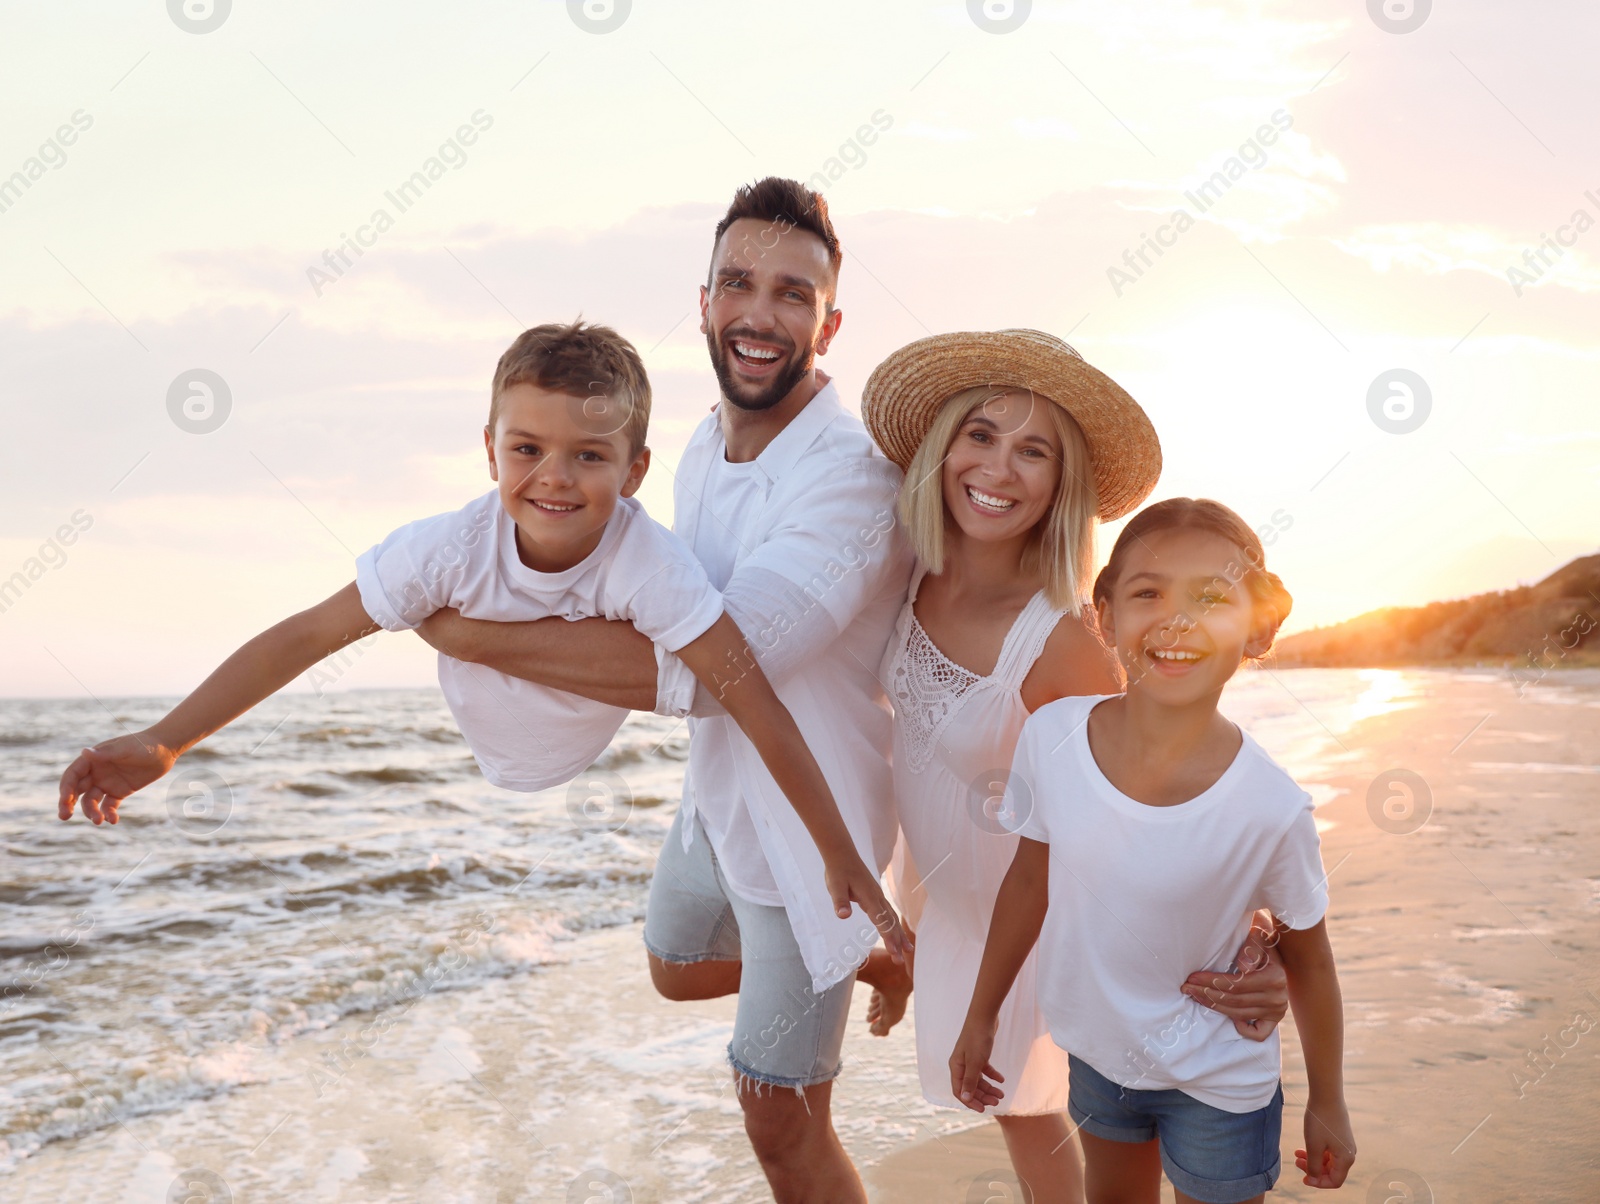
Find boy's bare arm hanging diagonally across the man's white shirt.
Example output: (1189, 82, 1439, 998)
(677, 613, 910, 962)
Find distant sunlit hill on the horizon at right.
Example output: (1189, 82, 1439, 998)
(1275, 554, 1600, 669)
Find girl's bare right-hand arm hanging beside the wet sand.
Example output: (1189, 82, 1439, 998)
(1278, 921, 1355, 1188)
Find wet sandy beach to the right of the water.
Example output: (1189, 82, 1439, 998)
(867, 671, 1600, 1204)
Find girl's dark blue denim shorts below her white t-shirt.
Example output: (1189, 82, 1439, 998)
(1067, 1055, 1283, 1204)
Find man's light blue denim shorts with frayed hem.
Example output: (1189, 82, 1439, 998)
(645, 810, 856, 1090)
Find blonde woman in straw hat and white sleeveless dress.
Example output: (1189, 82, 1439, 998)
(862, 331, 1286, 1204)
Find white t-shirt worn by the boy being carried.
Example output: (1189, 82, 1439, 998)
(355, 492, 722, 791)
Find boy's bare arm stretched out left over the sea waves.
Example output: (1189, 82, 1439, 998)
(59, 581, 379, 823)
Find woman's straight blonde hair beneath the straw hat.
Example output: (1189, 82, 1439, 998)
(899, 384, 1099, 615)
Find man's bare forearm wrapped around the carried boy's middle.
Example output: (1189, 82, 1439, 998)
(416, 608, 658, 711)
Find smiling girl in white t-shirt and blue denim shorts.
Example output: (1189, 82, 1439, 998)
(949, 498, 1355, 1204)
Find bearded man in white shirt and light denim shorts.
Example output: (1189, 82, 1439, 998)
(422, 178, 910, 1204)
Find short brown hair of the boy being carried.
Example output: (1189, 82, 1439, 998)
(490, 319, 650, 456)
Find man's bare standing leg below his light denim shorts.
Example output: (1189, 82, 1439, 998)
(734, 1071, 867, 1204)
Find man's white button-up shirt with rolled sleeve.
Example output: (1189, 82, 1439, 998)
(658, 384, 912, 991)
